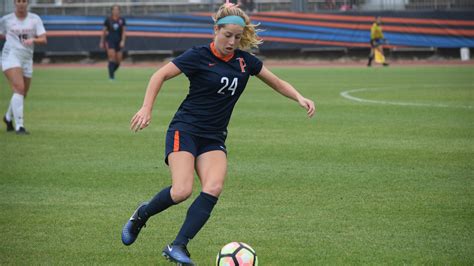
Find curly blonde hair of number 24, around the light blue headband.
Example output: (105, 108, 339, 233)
(212, 4, 263, 50)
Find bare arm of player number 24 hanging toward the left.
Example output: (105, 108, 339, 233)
(130, 62, 181, 132)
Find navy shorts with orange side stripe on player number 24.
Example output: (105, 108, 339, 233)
(165, 129, 227, 164)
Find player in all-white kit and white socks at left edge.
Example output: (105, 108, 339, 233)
(0, 0, 46, 135)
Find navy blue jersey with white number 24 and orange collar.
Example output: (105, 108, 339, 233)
(170, 43, 263, 141)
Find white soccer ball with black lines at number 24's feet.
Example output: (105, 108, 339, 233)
(216, 242, 258, 266)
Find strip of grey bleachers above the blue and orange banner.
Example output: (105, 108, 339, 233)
(30, 0, 474, 16)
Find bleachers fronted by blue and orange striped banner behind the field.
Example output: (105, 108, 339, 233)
(0, 0, 474, 61)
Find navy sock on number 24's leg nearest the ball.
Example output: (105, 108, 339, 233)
(173, 192, 217, 245)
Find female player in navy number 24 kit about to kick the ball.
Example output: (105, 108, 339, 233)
(122, 4, 315, 264)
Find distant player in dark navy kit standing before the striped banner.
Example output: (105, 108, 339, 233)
(99, 5, 126, 80)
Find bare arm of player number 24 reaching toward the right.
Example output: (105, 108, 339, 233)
(257, 66, 316, 117)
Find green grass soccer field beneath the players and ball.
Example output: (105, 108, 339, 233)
(0, 66, 474, 266)
